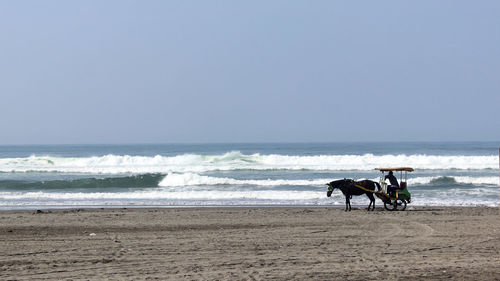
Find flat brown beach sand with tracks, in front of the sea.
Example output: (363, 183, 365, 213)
(0, 207, 500, 280)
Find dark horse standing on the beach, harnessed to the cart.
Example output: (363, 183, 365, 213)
(326, 179, 380, 212)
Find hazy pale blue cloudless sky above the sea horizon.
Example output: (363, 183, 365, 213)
(0, 0, 500, 144)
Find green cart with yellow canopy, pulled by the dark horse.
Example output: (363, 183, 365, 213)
(374, 167, 413, 211)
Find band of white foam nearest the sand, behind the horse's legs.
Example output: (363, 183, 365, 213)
(0, 188, 498, 209)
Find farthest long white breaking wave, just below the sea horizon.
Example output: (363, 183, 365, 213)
(0, 151, 498, 174)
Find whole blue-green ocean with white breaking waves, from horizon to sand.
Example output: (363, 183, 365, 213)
(0, 142, 500, 210)
